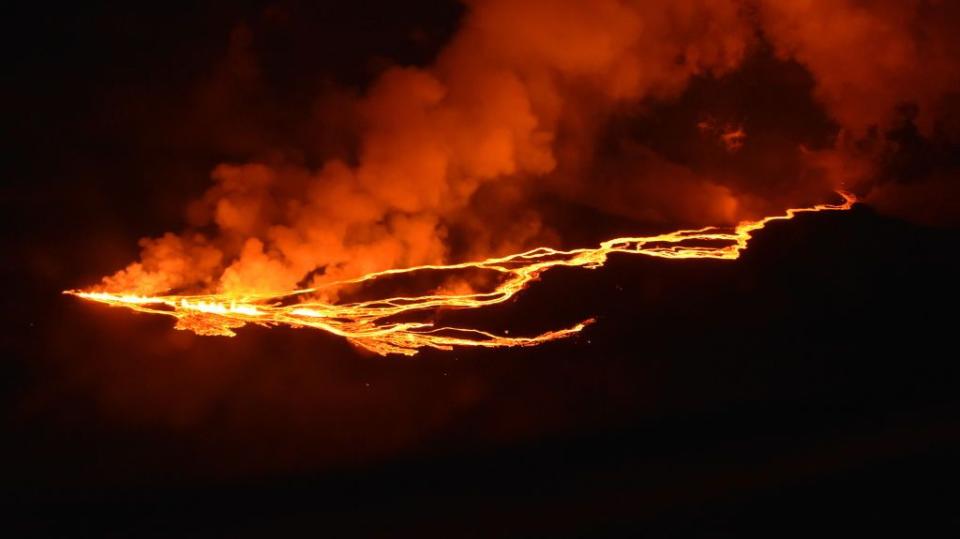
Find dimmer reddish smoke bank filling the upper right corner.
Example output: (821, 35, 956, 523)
(759, 0, 960, 223)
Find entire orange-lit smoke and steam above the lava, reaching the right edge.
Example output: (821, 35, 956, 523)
(97, 0, 960, 294)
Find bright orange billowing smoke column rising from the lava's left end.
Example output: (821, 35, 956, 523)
(99, 0, 750, 293)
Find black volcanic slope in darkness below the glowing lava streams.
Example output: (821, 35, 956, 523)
(2, 207, 960, 537)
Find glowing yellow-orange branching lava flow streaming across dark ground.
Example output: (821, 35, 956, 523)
(64, 192, 856, 356)
